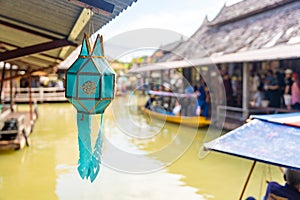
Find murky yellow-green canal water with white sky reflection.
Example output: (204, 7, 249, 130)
(0, 97, 283, 200)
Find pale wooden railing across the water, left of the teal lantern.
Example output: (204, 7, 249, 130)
(4, 87, 67, 103)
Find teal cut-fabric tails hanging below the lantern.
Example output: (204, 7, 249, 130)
(77, 113, 104, 182)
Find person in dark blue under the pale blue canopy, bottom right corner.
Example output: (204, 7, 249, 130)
(264, 169, 300, 200)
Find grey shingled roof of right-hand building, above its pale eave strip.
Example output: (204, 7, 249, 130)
(159, 0, 300, 62)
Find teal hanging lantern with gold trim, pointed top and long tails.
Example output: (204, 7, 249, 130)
(65, 34, 115, 182)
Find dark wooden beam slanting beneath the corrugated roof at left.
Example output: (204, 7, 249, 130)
(0, 40, 77, 61)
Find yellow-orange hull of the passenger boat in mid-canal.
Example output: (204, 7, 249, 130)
(142, 107, 210, 127)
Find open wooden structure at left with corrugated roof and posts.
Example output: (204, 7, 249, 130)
(0, 0, 137, 149)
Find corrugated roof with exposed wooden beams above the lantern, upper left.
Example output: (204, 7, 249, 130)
(0, 0, 137, 71)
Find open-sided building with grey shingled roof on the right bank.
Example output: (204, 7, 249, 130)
(131, 0, 300, 129)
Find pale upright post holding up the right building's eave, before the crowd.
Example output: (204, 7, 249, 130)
(243, 62, 250, 119)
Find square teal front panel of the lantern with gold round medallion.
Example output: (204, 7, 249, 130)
(78, 75, 101, 98)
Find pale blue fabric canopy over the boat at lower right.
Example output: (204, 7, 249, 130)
(204, 112, 300, 170)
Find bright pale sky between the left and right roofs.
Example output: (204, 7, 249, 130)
(60, 0, 241, 66)
